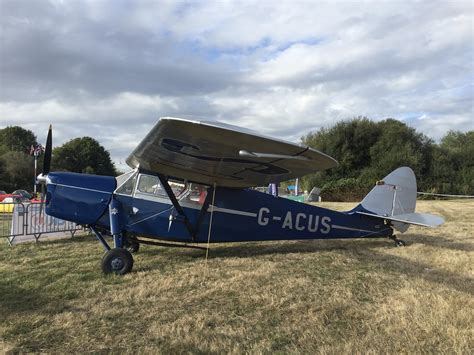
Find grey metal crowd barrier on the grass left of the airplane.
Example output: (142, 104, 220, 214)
(0, 203, 82, 245)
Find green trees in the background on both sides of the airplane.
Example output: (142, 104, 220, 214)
(0, 117, 474, 201)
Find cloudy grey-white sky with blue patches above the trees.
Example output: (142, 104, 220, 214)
(0, 0, 474, 169)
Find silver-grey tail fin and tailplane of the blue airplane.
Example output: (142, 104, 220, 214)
(354, 167, 444, 233)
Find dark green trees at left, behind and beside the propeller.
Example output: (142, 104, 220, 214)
(0, 126, 117, 192)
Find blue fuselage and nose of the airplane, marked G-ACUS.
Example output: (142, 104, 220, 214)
(46, 173, 393, 243)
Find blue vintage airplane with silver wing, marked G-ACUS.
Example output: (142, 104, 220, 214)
(38, 117, 443, 274)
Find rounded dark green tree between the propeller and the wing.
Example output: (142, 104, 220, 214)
(52, 137, 116, 175)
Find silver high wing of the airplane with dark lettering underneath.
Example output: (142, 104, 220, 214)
(127, 117, 337, 187)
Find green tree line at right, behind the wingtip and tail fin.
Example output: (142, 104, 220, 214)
(301, 117, 474, 201)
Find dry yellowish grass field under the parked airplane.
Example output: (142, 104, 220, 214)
(0, 200, 474, 354)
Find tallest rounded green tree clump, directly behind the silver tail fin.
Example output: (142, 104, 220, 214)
(302, 117, 433, 198)
